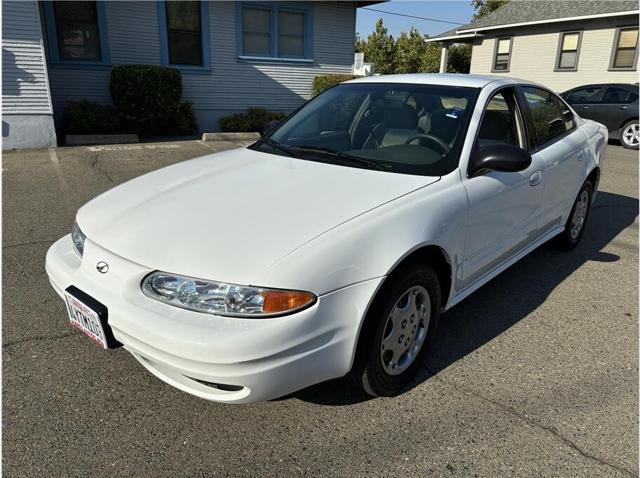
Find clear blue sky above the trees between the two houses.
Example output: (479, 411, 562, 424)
(356, 0, 474, 38)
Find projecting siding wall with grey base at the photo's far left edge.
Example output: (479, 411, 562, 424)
(2, 1, 56, 149)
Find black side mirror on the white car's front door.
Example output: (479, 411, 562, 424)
(469, 144, 531, 177)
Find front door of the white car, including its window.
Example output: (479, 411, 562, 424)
(462, 87, 545, 288)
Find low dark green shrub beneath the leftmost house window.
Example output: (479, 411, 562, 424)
(62, 101, 124, 134)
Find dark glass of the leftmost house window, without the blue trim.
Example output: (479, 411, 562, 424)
(52, 1, 101, 61)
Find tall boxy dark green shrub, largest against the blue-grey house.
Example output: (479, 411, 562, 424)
(109, 65, 197, 135)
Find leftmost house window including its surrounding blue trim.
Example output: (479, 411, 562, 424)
(43, 1, 109, 64)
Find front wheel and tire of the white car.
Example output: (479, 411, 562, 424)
(351, 264, 441, 397)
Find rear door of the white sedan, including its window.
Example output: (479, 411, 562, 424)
(521, 86, 590, 234)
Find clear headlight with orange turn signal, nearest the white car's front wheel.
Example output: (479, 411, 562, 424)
(142, 272, 317, 318)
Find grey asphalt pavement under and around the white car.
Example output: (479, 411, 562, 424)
(2, 141, 638, 477)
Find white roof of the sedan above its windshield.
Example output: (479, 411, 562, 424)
(345, 73, 532, 88)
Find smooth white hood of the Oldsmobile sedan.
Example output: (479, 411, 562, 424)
(77, 148, 439, 285)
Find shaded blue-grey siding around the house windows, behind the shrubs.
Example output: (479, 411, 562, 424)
(49, 1, 356, 131)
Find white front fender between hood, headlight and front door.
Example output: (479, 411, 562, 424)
(255, 171, 467, 300)
